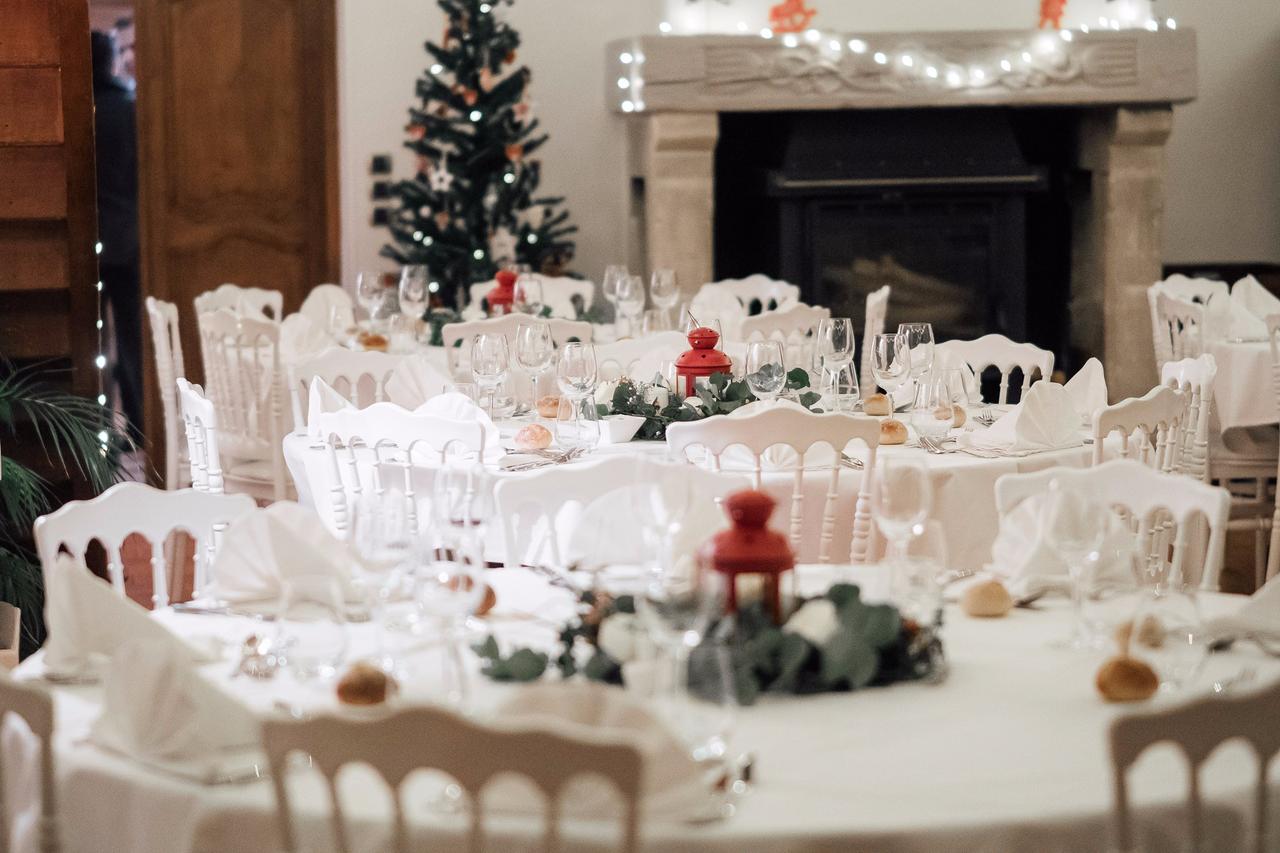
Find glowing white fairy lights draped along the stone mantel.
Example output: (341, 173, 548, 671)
(617, 17, 1178, 113)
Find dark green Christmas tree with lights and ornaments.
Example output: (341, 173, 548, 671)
(383, 0, 577, 307)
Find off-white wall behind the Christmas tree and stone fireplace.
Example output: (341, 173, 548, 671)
(338, 0, 1280, 289)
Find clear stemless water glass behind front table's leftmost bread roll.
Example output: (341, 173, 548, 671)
(275, 575, 348, 681)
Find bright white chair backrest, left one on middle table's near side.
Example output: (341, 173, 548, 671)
(312, 403, 485, 534)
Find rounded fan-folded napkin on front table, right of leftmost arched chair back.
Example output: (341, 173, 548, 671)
(209, 501, 356, 603)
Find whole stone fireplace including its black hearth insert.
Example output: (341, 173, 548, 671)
(608, 29, 1196, 398)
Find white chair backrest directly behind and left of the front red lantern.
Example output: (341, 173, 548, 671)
(494, 456, 748, 569)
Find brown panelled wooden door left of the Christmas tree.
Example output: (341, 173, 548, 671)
(136, 0, 339, 470)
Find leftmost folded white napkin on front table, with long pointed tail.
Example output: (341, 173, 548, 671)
(44, 555, 212, 676)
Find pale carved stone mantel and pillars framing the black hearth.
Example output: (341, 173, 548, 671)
(605, 29, 1197, 398)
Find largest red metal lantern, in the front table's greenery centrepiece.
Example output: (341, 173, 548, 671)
(700, 489, 796, 625)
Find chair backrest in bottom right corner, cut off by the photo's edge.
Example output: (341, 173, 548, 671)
(1107, 683, 1280, 853)
